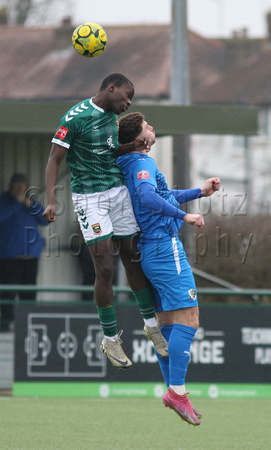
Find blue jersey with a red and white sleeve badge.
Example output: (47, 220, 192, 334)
(117, 153, 183, 242)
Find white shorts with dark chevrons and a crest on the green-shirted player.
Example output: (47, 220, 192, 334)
(72, 186, 140, 245)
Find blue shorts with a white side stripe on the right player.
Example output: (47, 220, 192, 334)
(141, 237, 198, 311)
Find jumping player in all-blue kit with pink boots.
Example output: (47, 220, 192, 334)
(117, 112, 220, 425)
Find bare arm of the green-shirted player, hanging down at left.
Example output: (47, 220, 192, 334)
(43, 144, 67, 222)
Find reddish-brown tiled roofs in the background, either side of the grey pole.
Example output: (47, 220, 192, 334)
(0, 22, 271, 105)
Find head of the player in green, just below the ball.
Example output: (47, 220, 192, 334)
(99, 73, 135, 115)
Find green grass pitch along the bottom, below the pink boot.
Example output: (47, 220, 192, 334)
(0, 397, 271, 450)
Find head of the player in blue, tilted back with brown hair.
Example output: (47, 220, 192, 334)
(119, 112, 155, 147)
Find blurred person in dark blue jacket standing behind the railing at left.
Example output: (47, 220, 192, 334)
(0, 173, 48, 331)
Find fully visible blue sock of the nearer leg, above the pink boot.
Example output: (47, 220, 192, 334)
(168, 323, 197, 386)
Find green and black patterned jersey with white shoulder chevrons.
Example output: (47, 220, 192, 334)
(52, 99, 125, 194)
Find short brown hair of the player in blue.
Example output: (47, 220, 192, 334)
(119, 112, 145, 144)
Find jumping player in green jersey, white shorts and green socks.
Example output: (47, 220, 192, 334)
(43, 73, 168, 369)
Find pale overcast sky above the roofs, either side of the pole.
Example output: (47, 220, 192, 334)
(68, 0, 271, 37)
